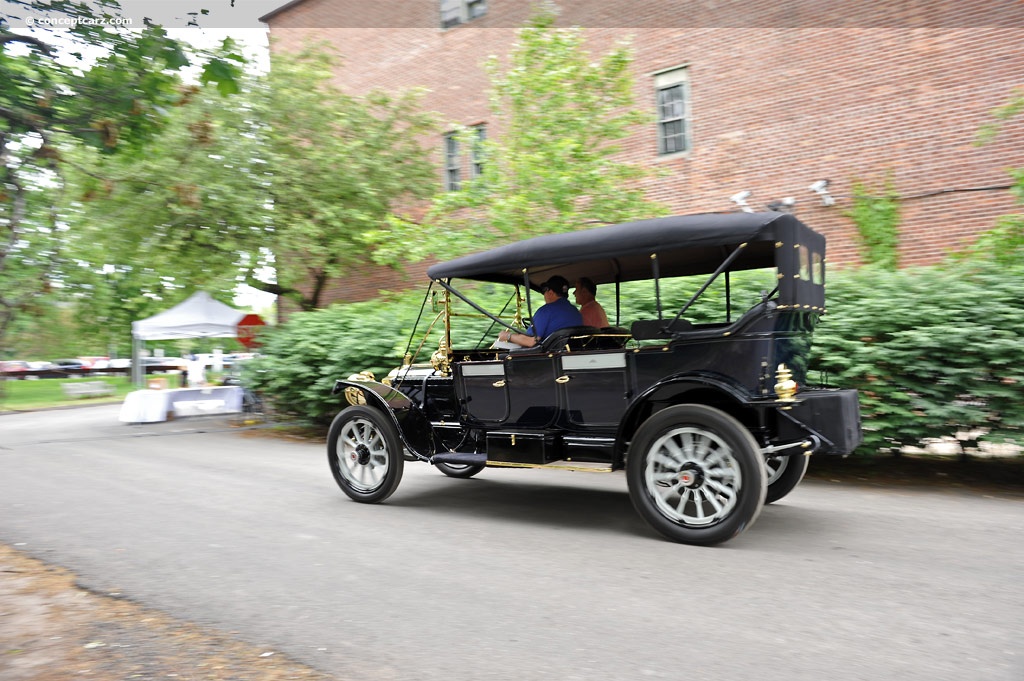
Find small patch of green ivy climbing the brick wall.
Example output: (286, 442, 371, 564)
(843, 175, 900, 270)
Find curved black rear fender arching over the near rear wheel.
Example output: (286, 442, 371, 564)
(614, 372, 757, 465)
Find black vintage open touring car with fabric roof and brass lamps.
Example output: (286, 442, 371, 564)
(328, 212, 861, 545)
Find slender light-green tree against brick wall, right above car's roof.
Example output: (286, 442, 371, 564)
(371, 12, 666, 263)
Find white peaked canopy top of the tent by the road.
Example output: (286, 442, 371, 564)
(131, 291, 246, 340)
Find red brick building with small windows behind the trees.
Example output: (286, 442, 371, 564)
(262, 0, 1024, 300)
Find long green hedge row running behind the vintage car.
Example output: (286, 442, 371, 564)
(247, 263, 1024, 454)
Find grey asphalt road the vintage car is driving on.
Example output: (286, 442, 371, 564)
(0, 407, 1024, 681)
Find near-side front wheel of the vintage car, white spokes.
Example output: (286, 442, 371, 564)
(327, 406, 404, 504)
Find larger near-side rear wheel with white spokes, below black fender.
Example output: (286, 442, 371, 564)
(626, 405, 767, 545)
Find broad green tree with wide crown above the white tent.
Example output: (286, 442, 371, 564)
(58, 45, 433, 311)
